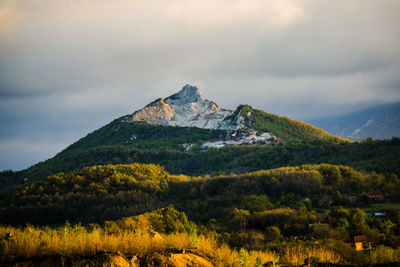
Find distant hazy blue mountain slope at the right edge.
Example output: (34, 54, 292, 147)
(309, 103, 400, 139)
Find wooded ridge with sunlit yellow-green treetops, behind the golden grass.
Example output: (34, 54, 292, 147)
(0, 164, 400, 225)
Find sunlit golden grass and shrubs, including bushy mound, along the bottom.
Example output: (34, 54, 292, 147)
(0, 207, 400, 266)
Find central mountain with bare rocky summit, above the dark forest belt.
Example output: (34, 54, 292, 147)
(56, 85, 344, 153)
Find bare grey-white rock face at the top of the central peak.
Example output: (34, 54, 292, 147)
(128, 85, 236, 129)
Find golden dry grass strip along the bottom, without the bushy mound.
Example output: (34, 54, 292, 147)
(0, 225, 400, 266)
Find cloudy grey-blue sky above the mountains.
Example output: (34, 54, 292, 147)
(0, 0, 400, 170)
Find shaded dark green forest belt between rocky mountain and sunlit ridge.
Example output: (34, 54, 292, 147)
(0, 137, 400, 188)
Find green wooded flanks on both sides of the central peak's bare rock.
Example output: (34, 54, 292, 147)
(61, 105, 346, 157)
